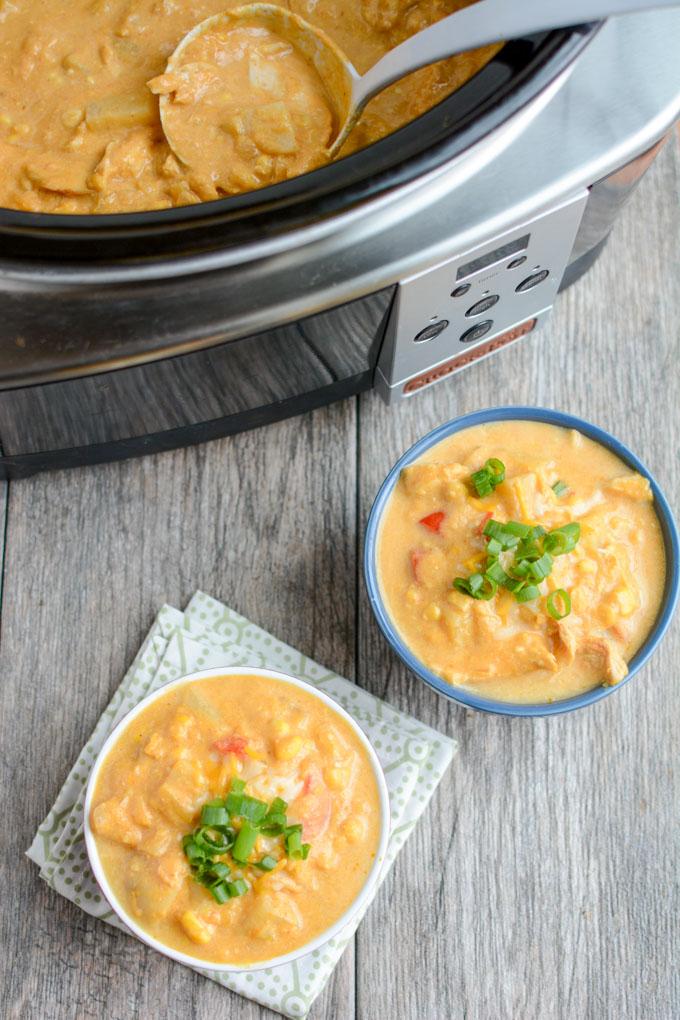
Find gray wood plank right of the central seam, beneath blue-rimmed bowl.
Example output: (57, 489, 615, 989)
(357, 137, 680, 1020)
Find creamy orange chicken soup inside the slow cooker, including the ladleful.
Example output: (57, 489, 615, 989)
(0, 0, 499, 213)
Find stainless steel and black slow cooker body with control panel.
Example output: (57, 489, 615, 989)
(0, 10, 680, 477)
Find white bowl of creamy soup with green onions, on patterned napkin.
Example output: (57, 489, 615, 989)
(85, 668, 389, 971)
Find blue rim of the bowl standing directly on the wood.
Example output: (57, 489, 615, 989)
(364, 405, 680, 716)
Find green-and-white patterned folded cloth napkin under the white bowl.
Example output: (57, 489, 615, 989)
(28, 592, 456, 1018)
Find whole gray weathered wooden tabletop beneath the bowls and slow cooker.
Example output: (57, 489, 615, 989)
(0, 137, 680, 1020)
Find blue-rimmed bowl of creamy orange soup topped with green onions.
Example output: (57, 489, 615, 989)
(364, 407, 679, 715)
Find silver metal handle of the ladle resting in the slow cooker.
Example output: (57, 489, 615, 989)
(354, 0, 680, 109)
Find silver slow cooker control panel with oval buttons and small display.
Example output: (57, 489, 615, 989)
(376, 189, 588, 403)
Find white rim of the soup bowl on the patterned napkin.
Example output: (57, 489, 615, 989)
(84, 667, 389, 972)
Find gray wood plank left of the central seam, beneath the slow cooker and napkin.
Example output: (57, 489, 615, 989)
(0, 401, 356, 1020)
